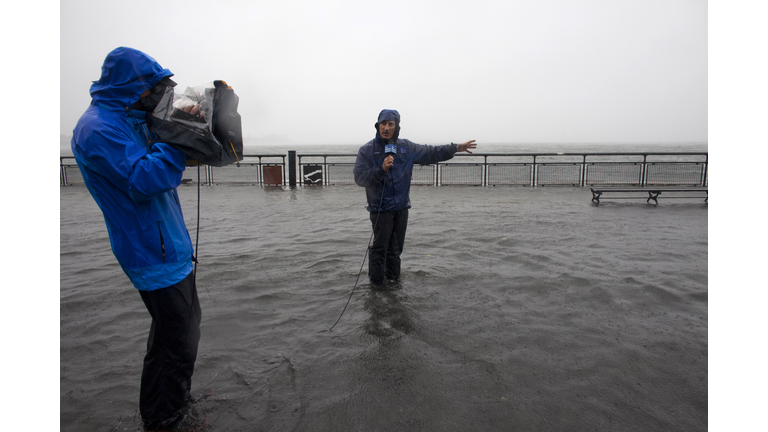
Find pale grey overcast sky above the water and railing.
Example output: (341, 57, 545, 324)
(60, 0, 707, 145)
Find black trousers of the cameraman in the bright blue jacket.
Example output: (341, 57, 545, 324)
(139, 273, 201, 429)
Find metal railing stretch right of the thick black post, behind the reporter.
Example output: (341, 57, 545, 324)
(298, 153, 708, 186)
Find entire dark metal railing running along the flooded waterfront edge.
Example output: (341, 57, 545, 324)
(61, 152, 709, 187)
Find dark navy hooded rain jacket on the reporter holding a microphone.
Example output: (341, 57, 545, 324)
(353, 110, 457, 213)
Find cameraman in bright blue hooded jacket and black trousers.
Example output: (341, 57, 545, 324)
(72, 47, 201, 430)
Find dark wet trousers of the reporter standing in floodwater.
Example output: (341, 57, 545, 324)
(368, 209, 408, 283)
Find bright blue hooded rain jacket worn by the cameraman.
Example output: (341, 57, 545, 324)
(72, 47, 193, 291)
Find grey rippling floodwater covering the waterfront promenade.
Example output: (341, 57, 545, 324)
(60, 185, 708, 431)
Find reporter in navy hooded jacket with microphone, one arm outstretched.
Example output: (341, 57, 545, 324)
(354, 109, 477, 285)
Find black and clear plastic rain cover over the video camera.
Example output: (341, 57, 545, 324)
(149, 81, 243, 166)
